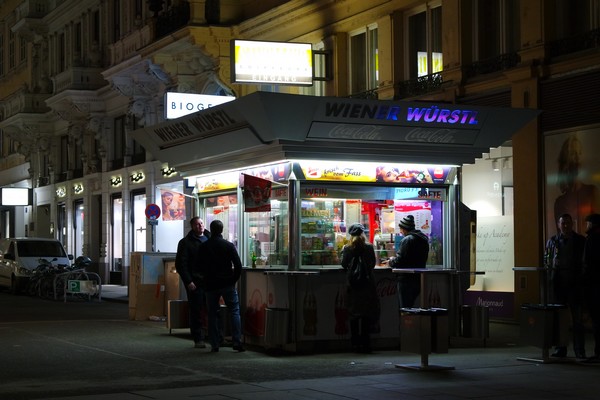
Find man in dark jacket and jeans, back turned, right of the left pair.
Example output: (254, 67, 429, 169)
(200, 220, 245, 352)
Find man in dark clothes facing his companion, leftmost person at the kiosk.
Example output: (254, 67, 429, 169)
(175, 217, 210, 349)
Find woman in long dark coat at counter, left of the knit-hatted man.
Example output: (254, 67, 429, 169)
(342, 224, 380, 353)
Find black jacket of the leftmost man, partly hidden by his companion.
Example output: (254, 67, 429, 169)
(175, 230, 210, 288)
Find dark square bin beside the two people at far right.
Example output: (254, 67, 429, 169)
(520, 304, 569, 348)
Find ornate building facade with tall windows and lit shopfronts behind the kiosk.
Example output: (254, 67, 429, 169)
(0, 0, 600, 318)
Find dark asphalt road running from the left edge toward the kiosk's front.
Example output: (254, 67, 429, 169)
(0, 291, 414, 399)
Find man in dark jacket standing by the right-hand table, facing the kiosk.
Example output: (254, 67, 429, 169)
(546, 214, 585, 358)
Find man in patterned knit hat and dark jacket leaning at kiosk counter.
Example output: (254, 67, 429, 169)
(388, 215, 429, 308)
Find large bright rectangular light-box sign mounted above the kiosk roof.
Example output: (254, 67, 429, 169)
(231, 39, 313, 86)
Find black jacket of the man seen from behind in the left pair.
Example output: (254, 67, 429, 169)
(200, 235, 242, 290)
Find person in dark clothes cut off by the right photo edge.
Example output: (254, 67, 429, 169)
(583, 214, 600, 362)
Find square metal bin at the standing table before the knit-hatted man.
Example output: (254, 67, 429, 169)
(400, 308, 448, 354)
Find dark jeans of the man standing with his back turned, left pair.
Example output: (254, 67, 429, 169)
(206, 286, 242, 349)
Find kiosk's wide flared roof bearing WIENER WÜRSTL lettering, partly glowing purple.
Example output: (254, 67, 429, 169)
(133, 92, 540, 173)
